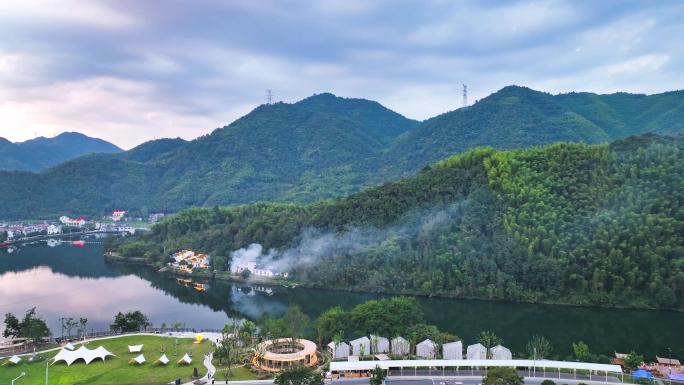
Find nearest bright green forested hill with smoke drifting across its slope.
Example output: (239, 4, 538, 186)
(110, 135, 684, 310)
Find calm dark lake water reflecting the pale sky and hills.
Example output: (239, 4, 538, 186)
(0, 238, 684, 360)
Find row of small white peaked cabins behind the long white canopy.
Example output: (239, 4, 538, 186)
(328, 335, 513, 361)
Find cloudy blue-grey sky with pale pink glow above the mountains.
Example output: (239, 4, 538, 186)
(0, 0, 684, 149)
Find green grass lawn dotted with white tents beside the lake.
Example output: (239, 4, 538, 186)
(0, 336, 216, 385)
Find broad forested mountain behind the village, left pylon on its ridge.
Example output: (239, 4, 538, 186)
(0, 94, 418, 218)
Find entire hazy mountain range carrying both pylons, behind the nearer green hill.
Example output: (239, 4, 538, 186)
(0, 86, 684, 219)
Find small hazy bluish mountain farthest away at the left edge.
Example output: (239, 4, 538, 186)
(0, 132, 122, 171)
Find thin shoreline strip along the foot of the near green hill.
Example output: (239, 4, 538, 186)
(105, 252, 684, 313)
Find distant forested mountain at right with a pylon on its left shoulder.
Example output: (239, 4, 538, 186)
(385, 86, 684, 175)
